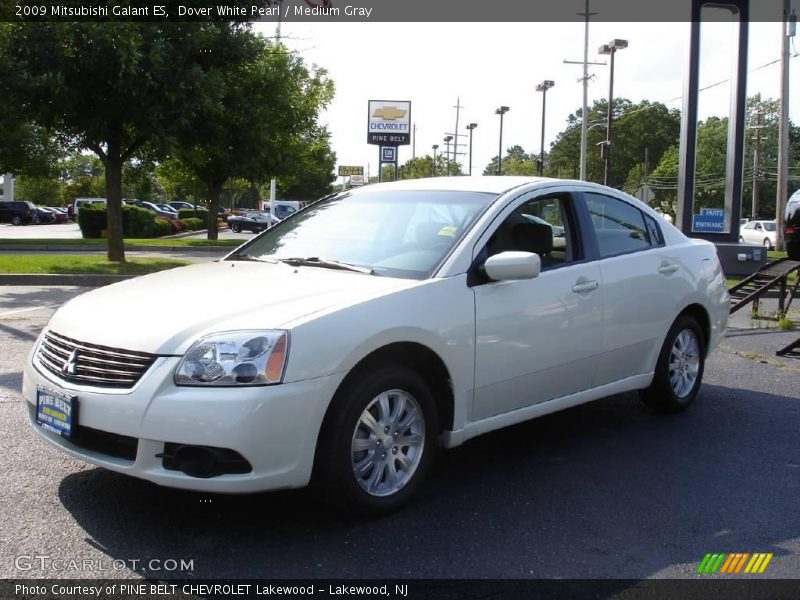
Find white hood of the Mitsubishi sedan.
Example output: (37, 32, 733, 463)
(48, 261, 420, 354)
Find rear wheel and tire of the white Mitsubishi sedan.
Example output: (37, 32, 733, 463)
(640, 315, 705, 413)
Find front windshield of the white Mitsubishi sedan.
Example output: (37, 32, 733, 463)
(228, 190, 497, 279)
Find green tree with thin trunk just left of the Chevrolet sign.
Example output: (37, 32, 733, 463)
(176, 36, 333, 240)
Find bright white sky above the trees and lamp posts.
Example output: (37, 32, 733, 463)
(254, 14, 800, 175)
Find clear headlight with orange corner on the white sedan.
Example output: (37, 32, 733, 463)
(175, 331, 289, 386)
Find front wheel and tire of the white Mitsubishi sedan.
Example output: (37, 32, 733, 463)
(315, 365, 438, 515)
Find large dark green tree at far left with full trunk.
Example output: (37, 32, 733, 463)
(0, 15, 260, 261)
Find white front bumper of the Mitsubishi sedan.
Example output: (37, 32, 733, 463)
(22, 357, 345, 494)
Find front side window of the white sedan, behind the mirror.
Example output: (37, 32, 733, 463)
(486, 194, 580, 271)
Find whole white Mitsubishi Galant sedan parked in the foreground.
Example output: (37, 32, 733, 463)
(23, 177, 729, 513)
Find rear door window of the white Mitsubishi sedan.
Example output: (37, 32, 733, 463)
(584, 193, 662, 258)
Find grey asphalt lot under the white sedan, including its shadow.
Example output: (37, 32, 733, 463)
(0, 287, 800, 579)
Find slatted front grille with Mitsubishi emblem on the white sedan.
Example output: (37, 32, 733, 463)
(37, 331, 158, 388)
